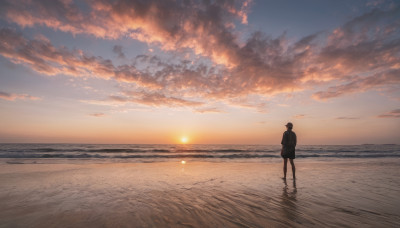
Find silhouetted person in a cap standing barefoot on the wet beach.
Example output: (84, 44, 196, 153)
(281, 122, 297, 179)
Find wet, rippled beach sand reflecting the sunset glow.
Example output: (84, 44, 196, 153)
(0, 159, 400, 227)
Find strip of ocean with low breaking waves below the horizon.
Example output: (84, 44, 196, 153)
(0, 144, 400, 162)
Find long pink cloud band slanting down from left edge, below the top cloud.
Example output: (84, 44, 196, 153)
(0, 29, 160, 88)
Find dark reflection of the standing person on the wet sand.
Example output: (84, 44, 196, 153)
(281, 179, 298, 222)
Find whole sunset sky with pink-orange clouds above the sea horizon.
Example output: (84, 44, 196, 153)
(0, 0, 400, 145)
